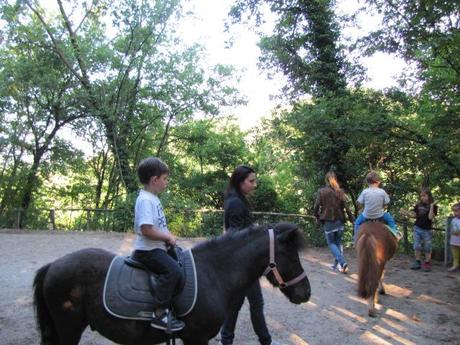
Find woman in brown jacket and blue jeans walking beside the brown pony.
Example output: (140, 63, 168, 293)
(314, 171, 354, 273)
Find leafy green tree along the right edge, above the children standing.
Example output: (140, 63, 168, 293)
(359, 0, 460, 178)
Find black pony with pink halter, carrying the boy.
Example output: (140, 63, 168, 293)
(34, 223, 310, 345)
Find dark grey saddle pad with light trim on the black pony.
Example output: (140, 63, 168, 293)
(102, 250, 198, 320)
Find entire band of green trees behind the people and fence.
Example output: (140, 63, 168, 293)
(0, 0, 454, 249)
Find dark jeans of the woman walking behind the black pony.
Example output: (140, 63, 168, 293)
(220, 281, 272, 345)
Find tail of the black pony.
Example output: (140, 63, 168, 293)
(33, 264, 59, 345)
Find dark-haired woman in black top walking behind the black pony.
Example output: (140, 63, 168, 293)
(220, 165, 279, 345)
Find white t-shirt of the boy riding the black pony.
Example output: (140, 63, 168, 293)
(134, 189, 169, 250)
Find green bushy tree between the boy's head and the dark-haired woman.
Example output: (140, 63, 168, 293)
(169, 119, 251, 209)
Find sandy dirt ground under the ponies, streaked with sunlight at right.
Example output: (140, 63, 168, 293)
(0, 230, 460, 345)
